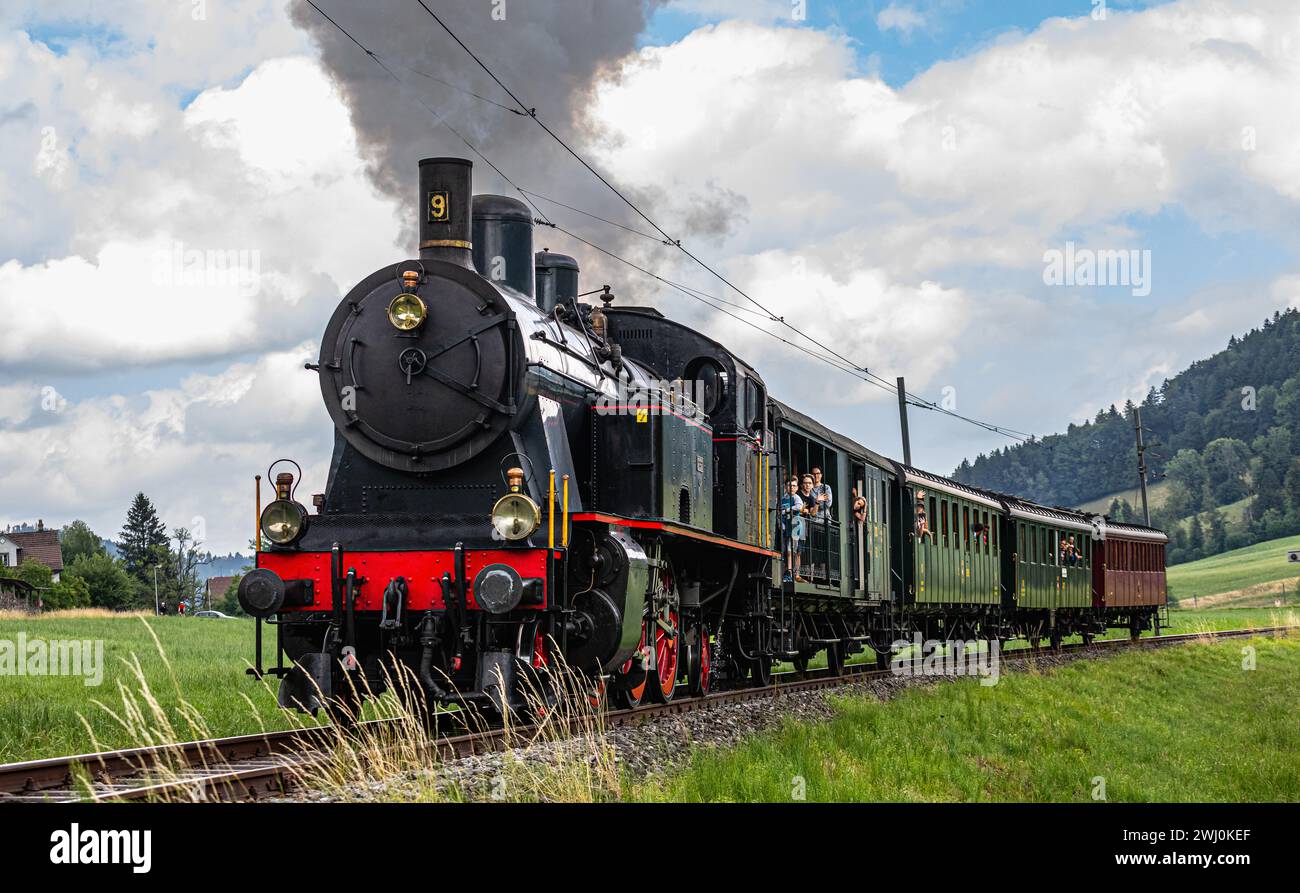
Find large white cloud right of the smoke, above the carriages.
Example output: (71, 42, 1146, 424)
(593, 0, 1300, 430)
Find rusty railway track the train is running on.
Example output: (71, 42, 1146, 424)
(0, 627, 1296, 803)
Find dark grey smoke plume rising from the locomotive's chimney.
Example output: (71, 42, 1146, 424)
(293, 0, 744, 304)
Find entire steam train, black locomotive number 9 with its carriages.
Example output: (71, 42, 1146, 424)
(238, 159, 1166, 712)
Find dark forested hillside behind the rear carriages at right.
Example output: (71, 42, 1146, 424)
(953, 309, 1300, 560)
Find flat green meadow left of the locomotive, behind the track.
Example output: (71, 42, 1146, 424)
(0, 614, 290, 763)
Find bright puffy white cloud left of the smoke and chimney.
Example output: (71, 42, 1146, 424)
(0, 50, 399, 370)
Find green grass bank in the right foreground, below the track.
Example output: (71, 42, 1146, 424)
(624, 638, 1300, 802)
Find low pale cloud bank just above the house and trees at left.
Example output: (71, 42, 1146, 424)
(0, 343, 330, 551)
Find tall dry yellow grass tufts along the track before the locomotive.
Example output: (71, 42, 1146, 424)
(67, 624, 619, 802)
